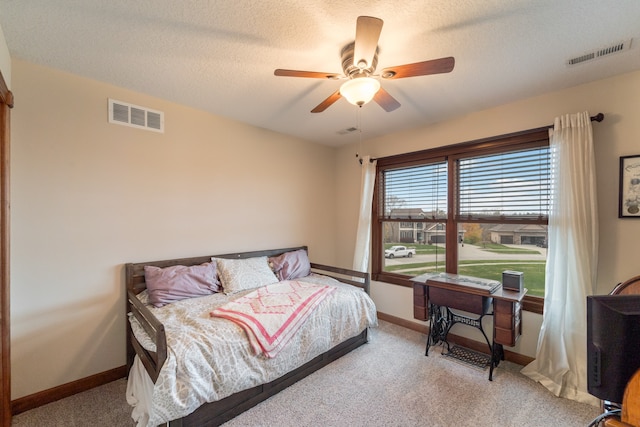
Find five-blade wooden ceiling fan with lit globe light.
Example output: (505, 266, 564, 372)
(274, 16, 455, 113)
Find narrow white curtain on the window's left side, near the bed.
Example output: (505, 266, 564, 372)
(353, 156, 377, 271)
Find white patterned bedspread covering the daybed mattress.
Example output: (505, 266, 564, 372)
(127, 274, 377, 426)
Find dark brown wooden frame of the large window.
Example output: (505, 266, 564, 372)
(371, 127, 549, 314)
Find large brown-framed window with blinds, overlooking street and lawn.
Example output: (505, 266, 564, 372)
(372, 128, 551, 312)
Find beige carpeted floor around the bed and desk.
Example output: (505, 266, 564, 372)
(12, 321, 600, 427)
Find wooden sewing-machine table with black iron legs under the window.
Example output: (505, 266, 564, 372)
(412, 273, 527, 381)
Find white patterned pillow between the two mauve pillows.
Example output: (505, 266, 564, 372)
(211, 256, 278, 295)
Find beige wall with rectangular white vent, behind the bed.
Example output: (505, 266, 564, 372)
(11, 58, 336, 399)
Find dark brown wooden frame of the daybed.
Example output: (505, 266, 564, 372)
(125, 246, 370, 427)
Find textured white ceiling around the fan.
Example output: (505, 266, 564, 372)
(0, 0, 640, 146)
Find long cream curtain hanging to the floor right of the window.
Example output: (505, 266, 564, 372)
(522, 112, 599, 405)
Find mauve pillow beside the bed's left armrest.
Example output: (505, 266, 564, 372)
(144, 262, 220, 307)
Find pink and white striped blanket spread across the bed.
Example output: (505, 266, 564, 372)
(210, 280, 336, 358)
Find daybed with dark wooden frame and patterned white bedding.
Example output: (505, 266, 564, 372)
(125, 246, 377, 427)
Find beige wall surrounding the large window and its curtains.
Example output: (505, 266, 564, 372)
(336, 68, 640, 357)
